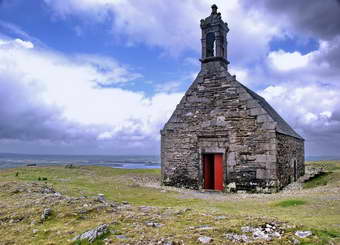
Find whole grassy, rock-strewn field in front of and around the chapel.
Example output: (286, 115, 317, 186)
(0, 162, 340, 244)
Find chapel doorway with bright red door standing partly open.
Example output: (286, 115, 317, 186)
(203, 154, 224, 191)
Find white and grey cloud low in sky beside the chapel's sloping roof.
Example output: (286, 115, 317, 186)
(260, 83, 340, 155)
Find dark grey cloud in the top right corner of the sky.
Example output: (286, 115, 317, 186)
(242, 0, 340, 40)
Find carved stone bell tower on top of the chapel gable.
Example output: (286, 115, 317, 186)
(200, 4, 229, 67)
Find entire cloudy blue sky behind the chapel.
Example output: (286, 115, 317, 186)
(0, 0, 340, 156)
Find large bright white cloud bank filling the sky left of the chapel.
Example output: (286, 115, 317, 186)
(0, 39, 182, 154)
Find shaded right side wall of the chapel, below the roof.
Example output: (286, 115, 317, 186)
(277, 133, 305, 188)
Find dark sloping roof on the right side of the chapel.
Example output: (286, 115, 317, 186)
(240, 83, 304, 140)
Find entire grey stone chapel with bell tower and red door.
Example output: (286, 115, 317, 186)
(161, 5, 305, 193)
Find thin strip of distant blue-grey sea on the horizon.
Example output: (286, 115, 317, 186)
(0, 153, 160, 169)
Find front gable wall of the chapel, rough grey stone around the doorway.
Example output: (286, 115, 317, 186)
(161, 61, 277, 191)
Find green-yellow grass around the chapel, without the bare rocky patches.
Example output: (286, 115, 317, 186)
(0, 162, 340, 244)
